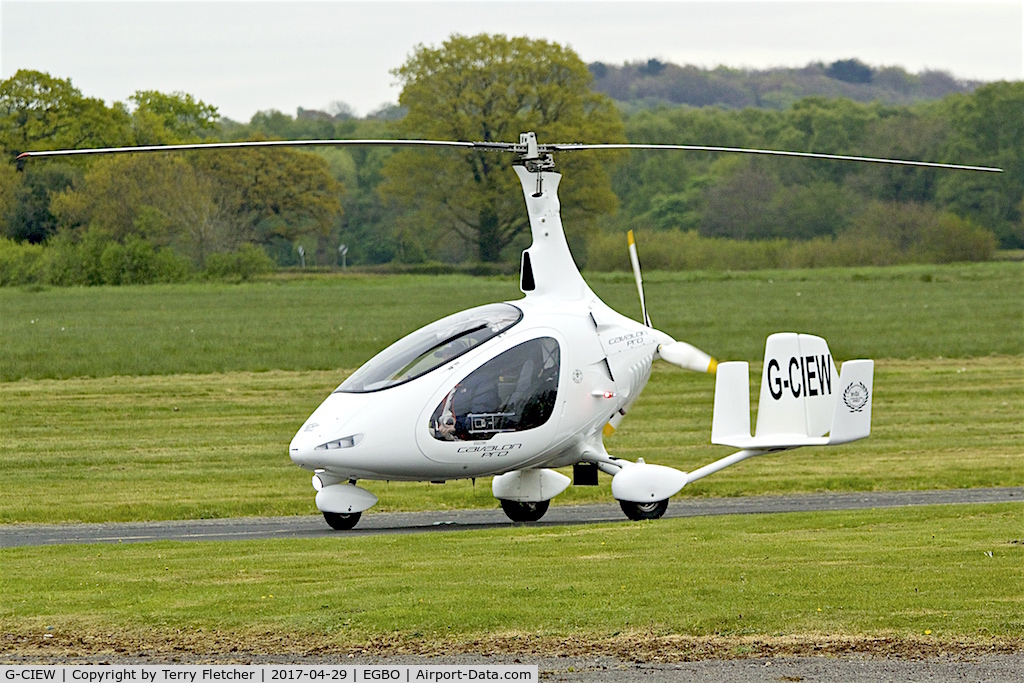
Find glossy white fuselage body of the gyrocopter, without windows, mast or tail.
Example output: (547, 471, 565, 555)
(290, 294, 671, 480)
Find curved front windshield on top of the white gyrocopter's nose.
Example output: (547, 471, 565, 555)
(337, 303, 522, 393)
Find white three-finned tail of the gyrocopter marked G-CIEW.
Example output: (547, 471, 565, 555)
(712, 333, 874, 450)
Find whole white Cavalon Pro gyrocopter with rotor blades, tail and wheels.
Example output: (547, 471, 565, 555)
(18, 133, 1000, 529)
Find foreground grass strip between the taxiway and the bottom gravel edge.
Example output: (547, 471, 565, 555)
(0, 505, 1024, 657)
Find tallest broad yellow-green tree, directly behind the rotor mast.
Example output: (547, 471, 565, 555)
(383, 35, 625, 261)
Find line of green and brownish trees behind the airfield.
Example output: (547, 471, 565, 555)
(0, 36, 1024, 284)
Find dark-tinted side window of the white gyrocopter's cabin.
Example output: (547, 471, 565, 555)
(428, 337, 559, 441)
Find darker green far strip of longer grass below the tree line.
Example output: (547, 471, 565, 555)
(0, 262, 1024, 381)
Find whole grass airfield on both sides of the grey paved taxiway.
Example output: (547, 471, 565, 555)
(0, 263, 1024, 656)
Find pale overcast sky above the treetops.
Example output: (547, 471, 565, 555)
(0, 0, 1024, 121)
